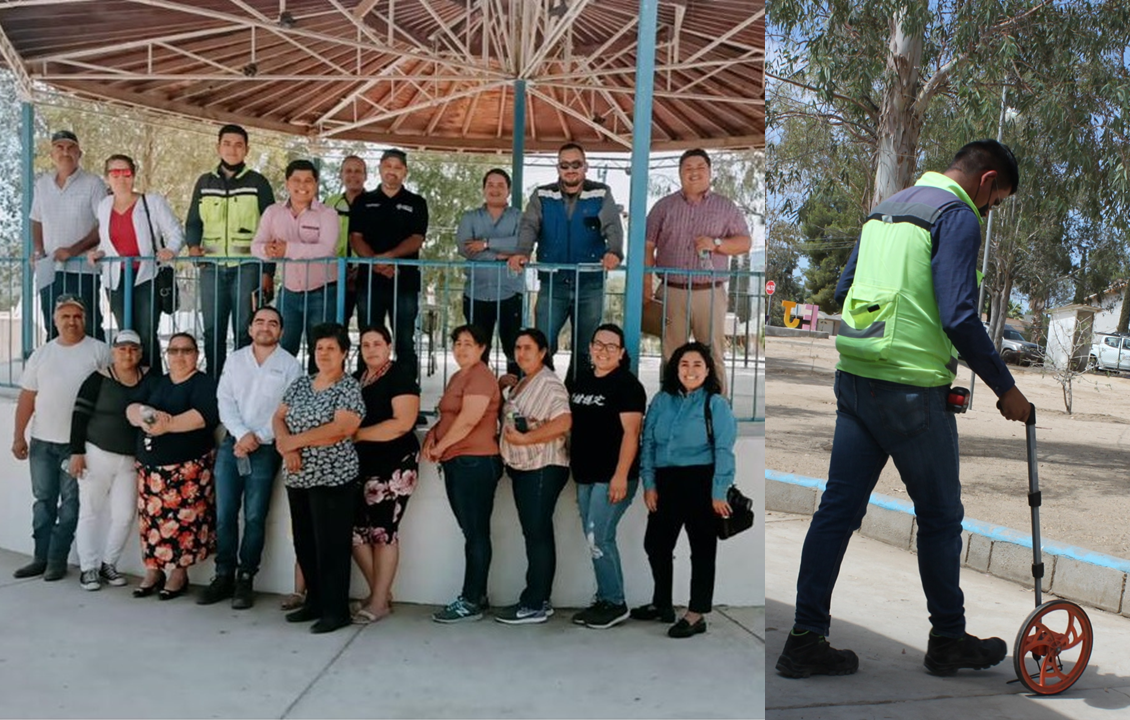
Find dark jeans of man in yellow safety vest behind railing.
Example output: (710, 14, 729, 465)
(200, 261, 263, 380)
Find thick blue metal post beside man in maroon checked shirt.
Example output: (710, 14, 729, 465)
(624, 0, 659, 370)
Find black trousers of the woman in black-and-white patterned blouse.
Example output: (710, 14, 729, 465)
(286, 482, 357, 622)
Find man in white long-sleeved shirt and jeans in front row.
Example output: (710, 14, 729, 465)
(197, 302, 302, 610)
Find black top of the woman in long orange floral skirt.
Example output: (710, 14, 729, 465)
(137, 371, 219, 467)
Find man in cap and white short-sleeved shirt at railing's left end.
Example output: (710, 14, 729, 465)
(31, 130, 106, 340)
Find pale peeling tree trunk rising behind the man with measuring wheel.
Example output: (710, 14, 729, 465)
(871, 10, 924, 207)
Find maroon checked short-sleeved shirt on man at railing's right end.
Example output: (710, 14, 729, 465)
(645, 190, 749, 285)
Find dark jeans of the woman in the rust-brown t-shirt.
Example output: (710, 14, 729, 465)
(443, 456, 502, 605)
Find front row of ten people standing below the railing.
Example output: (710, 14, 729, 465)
(12, 285, 737, 637)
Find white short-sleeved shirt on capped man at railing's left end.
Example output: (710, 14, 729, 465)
(32, 167, 106, 274)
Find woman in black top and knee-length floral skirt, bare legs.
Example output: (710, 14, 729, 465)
(353, 326, 420, 625)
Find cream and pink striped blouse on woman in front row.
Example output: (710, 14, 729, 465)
(498, 367, 570, 470)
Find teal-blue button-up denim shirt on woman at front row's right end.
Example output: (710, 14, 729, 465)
(640, 388, 738, 500)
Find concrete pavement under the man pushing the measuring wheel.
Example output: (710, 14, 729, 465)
(765, 512, 1130, 720)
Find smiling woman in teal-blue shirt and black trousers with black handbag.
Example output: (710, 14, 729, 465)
(632, 342, 738, 637)
